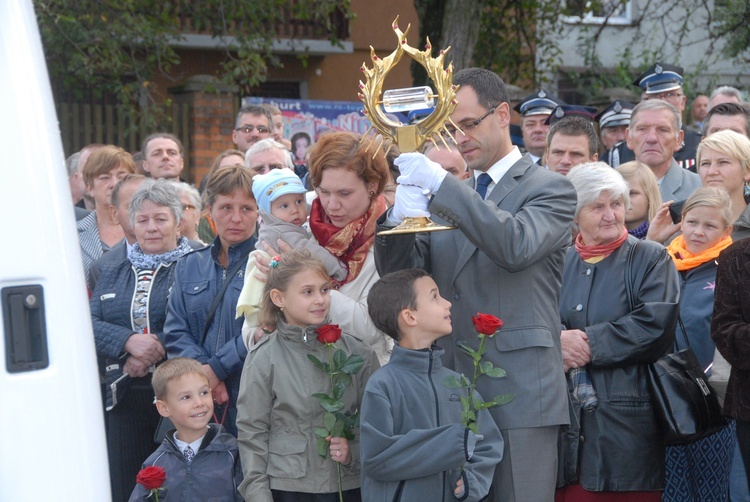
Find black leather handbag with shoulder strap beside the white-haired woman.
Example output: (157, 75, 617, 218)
(625, 243, 727, 446)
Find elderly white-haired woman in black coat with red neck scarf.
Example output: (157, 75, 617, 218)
(555, 162, 679, 502)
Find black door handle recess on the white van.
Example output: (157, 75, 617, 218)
(0, 284, 49, 373)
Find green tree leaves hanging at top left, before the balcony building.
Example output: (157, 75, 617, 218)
(34, 0, 352, 131)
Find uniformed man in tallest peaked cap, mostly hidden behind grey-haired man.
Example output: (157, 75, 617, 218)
(610, 63, 701, 172)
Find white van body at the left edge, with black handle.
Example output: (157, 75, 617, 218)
(0, 0, 110, 501)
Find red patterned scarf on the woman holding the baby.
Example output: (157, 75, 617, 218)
(310, 195, 388, 289)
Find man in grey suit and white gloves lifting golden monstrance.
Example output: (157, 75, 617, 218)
(375, 68, 576, 501)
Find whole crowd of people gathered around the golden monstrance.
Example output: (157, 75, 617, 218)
(72, 68, 750, 502)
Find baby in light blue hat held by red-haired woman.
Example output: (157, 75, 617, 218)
(237, 168, 347, 342)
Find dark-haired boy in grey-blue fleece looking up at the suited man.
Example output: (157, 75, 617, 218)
(360, 269, 503, 502)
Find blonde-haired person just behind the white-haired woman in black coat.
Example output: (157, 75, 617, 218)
(617, 160, 661, 239)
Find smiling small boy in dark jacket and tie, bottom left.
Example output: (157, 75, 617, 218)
(130, 357, 242, 502)
